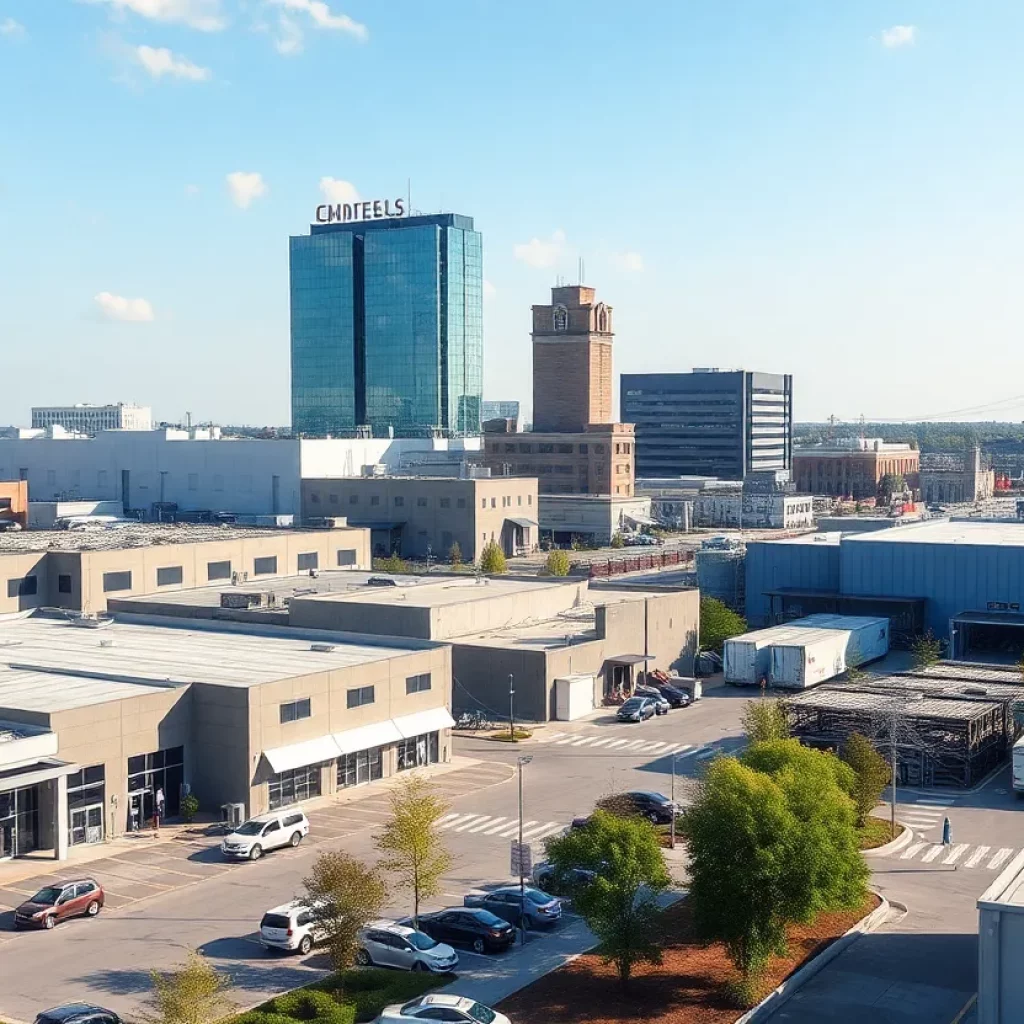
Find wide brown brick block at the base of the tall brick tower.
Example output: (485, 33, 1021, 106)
(483, 423, 636, 498)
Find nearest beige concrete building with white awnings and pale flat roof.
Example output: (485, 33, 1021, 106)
(0, 615, 453, 858)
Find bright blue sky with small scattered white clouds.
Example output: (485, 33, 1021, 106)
(0, 0, 1024, 424)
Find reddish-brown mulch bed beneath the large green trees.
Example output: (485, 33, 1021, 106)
(497, 894, 880, 1024)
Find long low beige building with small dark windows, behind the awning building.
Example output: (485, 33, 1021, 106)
(0, 524, 370, 616)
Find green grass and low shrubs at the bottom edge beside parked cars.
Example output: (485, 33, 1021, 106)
(221, 968, 452, 1024)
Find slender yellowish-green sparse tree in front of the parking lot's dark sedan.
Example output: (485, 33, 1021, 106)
(377, 775, 453, 922)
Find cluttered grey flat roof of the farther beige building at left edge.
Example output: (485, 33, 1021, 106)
(0, 521, 312, 557)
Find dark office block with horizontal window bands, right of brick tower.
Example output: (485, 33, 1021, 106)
(620, 370, 793, 480)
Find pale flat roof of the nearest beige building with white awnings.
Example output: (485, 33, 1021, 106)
(0, 615, 434, 717)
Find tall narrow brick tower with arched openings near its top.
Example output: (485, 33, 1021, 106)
(532, 285, 613, 432)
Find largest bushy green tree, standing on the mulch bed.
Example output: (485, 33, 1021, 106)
(681, 740, 867, 998)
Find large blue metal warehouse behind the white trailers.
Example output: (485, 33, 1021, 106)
(746, 520, 1024, 657)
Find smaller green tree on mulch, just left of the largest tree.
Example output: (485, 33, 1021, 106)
(547, 810, 672, 985)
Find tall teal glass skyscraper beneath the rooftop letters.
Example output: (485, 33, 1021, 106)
(289, 213, 483, 436)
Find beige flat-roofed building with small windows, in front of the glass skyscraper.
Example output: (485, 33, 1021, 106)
(302, 476, 538, 562)
